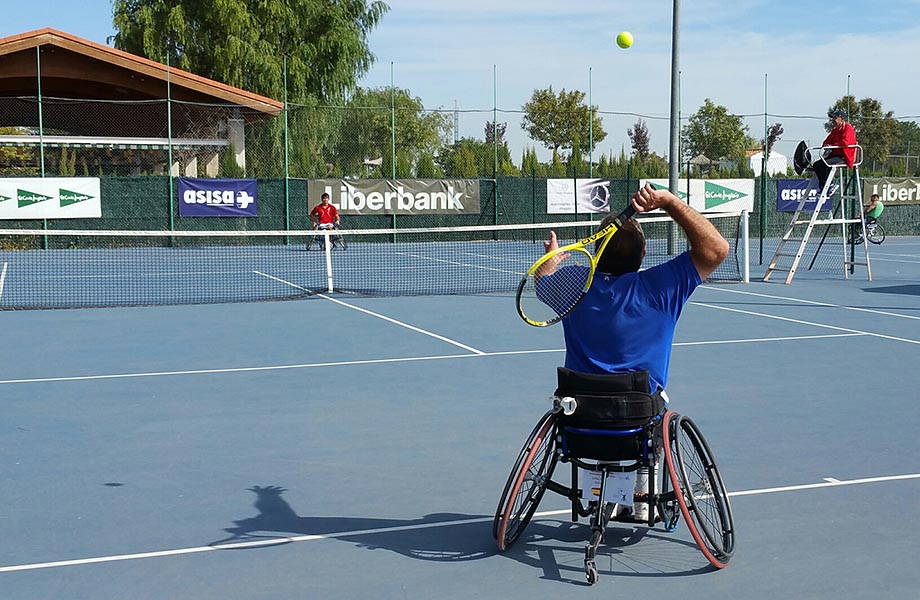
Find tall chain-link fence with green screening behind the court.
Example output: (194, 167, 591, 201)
(0, 97, 920, 244)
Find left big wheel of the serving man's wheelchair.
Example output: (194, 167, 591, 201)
(492, 411, 558, 552)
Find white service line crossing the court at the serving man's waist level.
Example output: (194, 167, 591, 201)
(0, 333, 861, 385)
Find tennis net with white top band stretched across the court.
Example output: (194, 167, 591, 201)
(0, 213, 748, 309)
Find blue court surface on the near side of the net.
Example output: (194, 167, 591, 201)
(0, 238, 920, 600)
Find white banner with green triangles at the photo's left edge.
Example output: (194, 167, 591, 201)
(0, 177, 102, 219)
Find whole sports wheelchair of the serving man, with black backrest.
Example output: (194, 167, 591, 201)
(492, 368, 735, 584)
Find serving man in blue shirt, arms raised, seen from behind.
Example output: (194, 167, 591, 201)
(544, 185, 729, 392)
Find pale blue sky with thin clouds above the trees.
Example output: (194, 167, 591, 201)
(0, 0, 920, 160)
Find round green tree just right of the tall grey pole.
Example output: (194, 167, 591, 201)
(681, 98, 756, 161)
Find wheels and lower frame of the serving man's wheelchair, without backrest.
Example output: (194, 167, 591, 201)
(492, 406, 735, 584)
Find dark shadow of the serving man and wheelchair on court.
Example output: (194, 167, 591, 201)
(211, 485, 710, 585)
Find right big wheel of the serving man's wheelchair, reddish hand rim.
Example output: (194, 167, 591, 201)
(662, 411, 735, 569)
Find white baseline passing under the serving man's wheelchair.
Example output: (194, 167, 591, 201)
(0, 473, 920, 573)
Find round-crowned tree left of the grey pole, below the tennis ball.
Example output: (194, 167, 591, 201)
(521, 86, 607, 156)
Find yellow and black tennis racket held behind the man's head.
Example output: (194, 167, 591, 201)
(517, 204, 636, 327)
